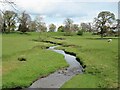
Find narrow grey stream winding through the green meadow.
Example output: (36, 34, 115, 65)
(29, 46, 83, 88)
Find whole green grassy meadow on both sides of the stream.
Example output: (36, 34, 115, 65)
(2, 32, 118, 88)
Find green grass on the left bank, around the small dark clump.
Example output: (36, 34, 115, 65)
(2, 33, 68, 88)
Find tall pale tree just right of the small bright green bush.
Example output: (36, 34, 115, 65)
(64, 18, 73, 35)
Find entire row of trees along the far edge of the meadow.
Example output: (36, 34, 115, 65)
(0, 10, 120, 38)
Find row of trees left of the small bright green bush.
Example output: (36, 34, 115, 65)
(0, 10, 56, 33)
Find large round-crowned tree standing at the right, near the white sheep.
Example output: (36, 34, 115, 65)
(95, 11, 115, 38)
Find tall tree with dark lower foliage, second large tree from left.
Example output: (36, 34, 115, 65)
(18, 12, 31, 33)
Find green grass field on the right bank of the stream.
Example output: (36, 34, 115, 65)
(39, 33, 118, 88)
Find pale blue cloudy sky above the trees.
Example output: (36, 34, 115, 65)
(0, 0, 119, 26)
